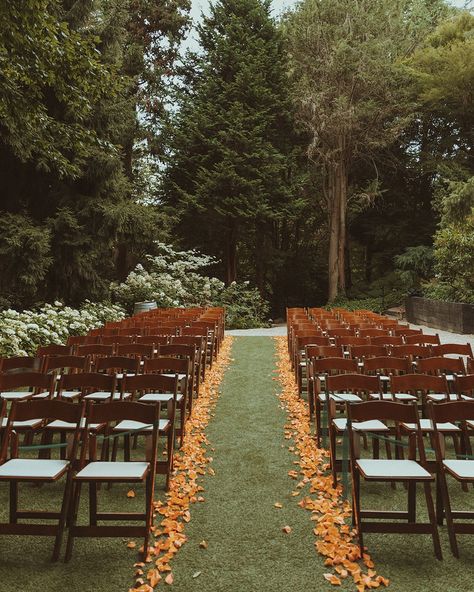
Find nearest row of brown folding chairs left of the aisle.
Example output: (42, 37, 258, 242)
(0, 400, 166, 560)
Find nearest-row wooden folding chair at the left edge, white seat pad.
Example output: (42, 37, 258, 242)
(0, 400, 84, 561)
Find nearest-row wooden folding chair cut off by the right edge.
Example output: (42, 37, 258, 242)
(428, 401, 474, 557)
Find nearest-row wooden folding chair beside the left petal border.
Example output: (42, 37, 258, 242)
(66, 398, 161, 561)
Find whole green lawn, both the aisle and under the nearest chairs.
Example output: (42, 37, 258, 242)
(0, 337, 474, 592)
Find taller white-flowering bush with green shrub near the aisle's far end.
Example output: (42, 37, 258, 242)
(111, 243, 269, 328)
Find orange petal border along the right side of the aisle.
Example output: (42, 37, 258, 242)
(275, 337, 389, 592)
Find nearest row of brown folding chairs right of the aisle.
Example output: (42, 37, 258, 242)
(347, 400, 474, 559)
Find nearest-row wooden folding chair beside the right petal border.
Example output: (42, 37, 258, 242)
(347, 401, 442, 559)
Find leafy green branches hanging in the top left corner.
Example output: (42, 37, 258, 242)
(0, 0, 116, 176)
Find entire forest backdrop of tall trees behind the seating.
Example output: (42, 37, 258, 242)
(0, 0, 474, 324)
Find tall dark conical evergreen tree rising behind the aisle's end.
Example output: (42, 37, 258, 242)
(162, 0, 292, 289)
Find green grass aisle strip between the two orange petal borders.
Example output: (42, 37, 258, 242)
(168, 337, 326, 592)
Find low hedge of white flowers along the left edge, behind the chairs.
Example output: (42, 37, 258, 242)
(0, 301, 125, 357)
